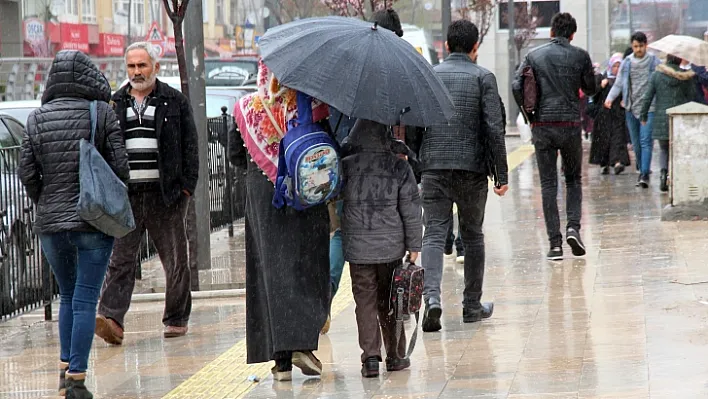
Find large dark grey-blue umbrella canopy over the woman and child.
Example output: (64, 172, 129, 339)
(258, 17, 454, 126)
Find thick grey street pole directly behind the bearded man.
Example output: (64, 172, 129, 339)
(183, 0, 211, 276)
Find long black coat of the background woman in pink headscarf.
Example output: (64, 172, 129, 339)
(588, 75, 630, 166)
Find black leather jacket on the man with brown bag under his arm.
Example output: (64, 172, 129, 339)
(512, 37, 602, 125)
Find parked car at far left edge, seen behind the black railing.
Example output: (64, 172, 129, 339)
(0, 114, 41, 316)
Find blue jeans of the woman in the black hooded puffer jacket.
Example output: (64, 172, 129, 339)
(39, 231, 114, 373)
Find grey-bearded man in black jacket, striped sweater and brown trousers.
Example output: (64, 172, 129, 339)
(96, 42, 199, 345)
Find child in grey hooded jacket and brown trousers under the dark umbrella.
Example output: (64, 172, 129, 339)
(342, 120, 423, 378)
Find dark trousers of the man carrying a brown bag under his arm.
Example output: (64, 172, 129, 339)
(532, 124, 583, 248)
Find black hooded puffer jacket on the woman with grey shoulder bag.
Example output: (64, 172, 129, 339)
(18, 51, 130, 234)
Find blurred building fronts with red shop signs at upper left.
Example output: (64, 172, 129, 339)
(0, 0, 236, 57)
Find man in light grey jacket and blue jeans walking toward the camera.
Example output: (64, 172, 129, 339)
(605, 32, 661, 188)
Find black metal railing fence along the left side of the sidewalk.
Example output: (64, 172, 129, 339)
(0, 110, 246, 321)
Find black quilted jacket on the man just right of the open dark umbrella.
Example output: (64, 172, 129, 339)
(419, 53, 508, 184)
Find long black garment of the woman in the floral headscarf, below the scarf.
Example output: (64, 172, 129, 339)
(229, 133, 330, 363)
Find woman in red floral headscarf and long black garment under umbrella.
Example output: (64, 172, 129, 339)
(229, 62, 330, 381)
